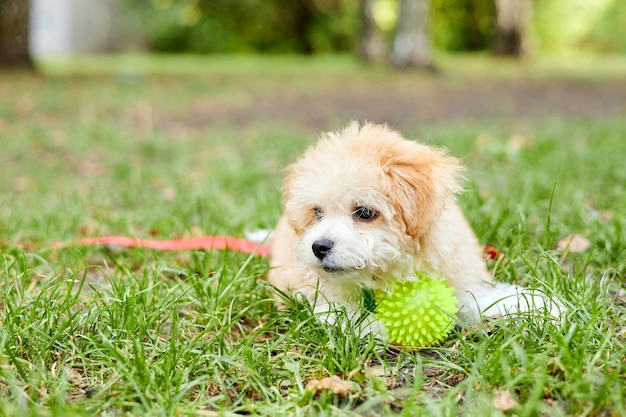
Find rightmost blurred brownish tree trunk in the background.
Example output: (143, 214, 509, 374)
(492, 0, 532, 57)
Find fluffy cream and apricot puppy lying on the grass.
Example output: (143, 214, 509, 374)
(268, 122, 543, 334)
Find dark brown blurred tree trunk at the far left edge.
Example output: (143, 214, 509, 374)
(0, 0, 33, 68)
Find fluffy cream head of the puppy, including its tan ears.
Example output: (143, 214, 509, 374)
(283, 123, 462, 288)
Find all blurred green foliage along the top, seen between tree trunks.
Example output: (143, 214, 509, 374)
(123, 0, 626, 54)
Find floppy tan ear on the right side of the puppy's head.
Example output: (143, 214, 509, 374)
(383, 141, 463, 238)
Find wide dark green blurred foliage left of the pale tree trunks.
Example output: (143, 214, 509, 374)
(125, 0, 359, 53)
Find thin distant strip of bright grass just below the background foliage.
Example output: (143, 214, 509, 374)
(38, 52, 626, 79)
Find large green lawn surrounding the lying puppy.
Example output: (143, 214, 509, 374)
(0, 53, 626, 416)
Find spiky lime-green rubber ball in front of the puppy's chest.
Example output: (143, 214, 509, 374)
(374, 276, 458, 347)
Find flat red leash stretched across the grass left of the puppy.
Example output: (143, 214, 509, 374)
(52, 236, 270, 257)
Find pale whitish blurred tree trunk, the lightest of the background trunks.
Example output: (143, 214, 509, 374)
(391, 0, 434, 70)
